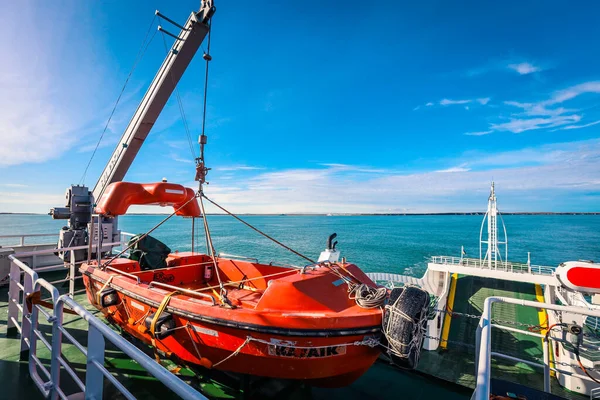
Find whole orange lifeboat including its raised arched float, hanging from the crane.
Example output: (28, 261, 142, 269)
(80, 182, 429, 387)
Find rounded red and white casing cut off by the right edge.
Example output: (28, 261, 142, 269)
(556, 260, 600, 293)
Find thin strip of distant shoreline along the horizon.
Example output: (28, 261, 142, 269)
(0, 211, 600, 217)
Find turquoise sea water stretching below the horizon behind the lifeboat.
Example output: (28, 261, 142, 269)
(0, 214, 600, 276)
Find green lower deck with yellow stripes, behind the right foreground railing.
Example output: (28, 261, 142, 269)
(418, 276, 587, 400)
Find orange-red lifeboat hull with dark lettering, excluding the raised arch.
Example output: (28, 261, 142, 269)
(81, 256, 381, 387)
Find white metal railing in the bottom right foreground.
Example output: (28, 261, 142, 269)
(472, 297, 600, 400)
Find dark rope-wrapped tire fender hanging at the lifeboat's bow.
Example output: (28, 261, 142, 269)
(381, 286, 430, 369)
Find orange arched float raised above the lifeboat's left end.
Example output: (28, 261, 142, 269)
(95, 182, 201, 217)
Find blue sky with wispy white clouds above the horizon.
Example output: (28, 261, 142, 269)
(0, 0, 600, 213)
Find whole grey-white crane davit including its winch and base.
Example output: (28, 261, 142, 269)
(50, 0, 215, 261)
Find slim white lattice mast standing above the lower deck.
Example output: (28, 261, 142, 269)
(479, 182, 508, 269)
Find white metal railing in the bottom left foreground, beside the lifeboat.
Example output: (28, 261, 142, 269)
(7, 255, 205, 400)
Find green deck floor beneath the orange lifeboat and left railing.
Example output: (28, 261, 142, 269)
(0, 273, 472, 400)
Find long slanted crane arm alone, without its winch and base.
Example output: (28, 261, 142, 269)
(93, 0, 215, 201)
